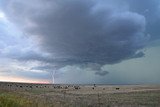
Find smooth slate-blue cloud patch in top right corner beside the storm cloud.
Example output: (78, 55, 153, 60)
(128, 0, 160, 40)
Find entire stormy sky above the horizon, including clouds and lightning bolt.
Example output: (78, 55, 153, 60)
(0, 0, 160, 84)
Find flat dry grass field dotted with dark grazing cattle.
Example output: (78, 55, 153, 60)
(0, 82, 160, 107)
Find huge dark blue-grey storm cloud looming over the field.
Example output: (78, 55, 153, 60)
(1, 0, 149, 67)
